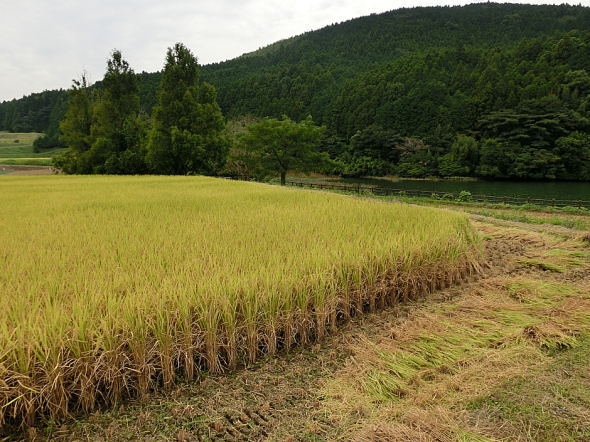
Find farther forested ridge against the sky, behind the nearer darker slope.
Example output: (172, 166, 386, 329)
(0, 3, 590, 131)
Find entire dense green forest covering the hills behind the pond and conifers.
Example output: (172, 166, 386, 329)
(0, 3, 590, 180)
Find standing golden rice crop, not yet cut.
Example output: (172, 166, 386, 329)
(0, 176, 481, 434)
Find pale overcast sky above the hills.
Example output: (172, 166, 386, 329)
(0, 0, 590, 101)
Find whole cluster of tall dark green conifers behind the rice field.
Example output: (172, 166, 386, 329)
(55, 44, 228, 174)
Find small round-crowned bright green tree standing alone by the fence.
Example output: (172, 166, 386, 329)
(240, 116, 329, 185)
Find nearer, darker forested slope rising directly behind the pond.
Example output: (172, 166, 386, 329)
(332, 32, 590, 180)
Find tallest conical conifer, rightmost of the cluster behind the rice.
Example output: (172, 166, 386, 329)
(147, 43, 229, 175)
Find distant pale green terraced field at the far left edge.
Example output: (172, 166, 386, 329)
(0, 132, 64, 166)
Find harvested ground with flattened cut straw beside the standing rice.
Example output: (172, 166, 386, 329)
(29, 219, 590, 441)
